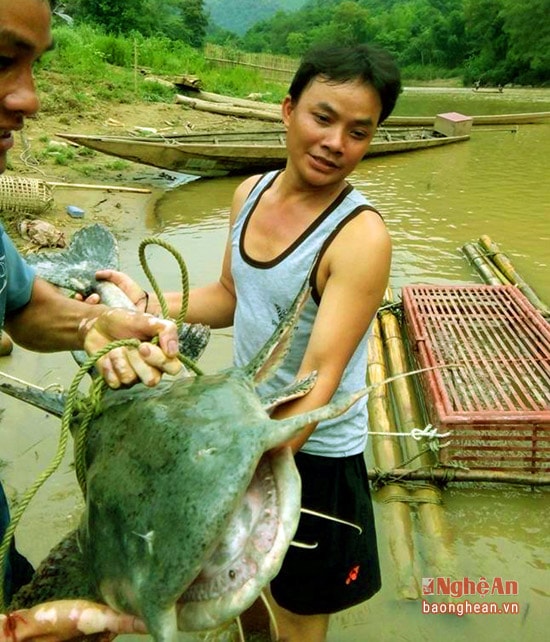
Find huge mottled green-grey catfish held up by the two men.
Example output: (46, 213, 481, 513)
(0, 224, 384, 642)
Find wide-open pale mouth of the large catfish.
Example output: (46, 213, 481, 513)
(177, 448, 301, 631)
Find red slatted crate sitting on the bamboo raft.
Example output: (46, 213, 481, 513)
(403, 285, 550, 472)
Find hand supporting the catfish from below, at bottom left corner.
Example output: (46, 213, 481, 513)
(0, 600, 147, 642)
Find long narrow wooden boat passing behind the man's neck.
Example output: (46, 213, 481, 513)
(58, 129, 469, 177)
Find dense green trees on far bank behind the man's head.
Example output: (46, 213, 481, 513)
(239, 0, 550, 85)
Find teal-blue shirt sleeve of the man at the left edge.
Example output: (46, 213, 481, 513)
(0, 225, 35, 328)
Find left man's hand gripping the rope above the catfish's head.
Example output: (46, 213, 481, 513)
(80, 308, 181, 388)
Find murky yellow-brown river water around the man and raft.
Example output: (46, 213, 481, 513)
(0, 90, 550, 642)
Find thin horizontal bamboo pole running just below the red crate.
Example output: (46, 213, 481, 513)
(368, 468, 550, 486)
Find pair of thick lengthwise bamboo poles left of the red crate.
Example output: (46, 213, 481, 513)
(367, 293, 462, 600)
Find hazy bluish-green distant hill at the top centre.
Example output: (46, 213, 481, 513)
(204, 0, 306, 35)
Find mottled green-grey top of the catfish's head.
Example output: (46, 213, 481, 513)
(80, 370, 276, 617)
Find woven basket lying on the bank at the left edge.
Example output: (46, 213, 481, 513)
(0, 176, 54, 214)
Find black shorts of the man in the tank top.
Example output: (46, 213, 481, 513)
(271, 453, 381, 615)
